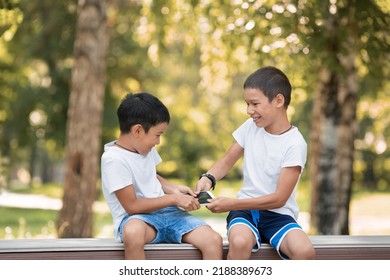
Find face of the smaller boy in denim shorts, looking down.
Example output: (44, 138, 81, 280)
(136, 123, 168, 155)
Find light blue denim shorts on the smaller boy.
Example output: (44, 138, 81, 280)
(118, 206, 207, 244)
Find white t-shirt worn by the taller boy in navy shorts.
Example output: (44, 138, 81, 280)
(233, 119, 307, 219)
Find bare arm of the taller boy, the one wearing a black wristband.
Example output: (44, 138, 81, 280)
(195, 142, 244, 194)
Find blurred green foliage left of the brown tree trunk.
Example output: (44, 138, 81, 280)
(0, 1, 76, 187)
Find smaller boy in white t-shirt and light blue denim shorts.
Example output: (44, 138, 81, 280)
(101, 93, 222, 259)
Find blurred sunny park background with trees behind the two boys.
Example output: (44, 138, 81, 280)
(0, 0, 390, 238)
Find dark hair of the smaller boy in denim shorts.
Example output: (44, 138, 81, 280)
(117, 92, 170, 134)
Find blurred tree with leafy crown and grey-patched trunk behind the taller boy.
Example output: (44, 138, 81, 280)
(302, 0, 390, 234)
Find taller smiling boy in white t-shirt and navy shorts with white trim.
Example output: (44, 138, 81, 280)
(195, 67, 315, 259)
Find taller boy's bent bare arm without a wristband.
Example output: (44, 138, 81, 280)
(207, 166, 301, 213)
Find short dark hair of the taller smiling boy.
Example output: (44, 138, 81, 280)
(244, 66, 291, 109)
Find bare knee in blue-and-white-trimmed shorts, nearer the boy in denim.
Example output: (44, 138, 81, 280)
(227, 225, 256, 260)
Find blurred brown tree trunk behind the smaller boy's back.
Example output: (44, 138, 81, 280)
(57, 0, 109, 237)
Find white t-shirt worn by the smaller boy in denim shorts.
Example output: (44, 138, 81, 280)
(101, 141, 164, 238)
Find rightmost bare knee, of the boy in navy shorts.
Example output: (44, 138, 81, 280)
(280, 230, 316, 260)
